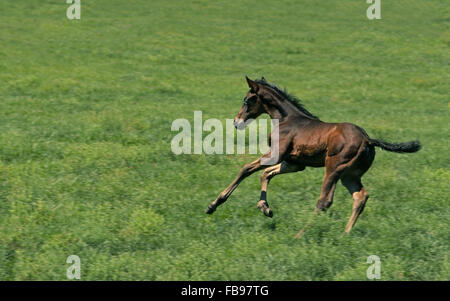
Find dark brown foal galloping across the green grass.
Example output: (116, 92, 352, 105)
(206, 77, 421, 237)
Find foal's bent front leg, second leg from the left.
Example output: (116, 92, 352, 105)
(258, 161, 305, 217)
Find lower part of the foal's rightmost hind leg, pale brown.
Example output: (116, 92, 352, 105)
(342, 177, 369, 233)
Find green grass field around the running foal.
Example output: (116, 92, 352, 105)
(0, 0, 450, 280)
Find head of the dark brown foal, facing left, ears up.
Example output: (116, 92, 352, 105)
(233, 76, 265, 130)
